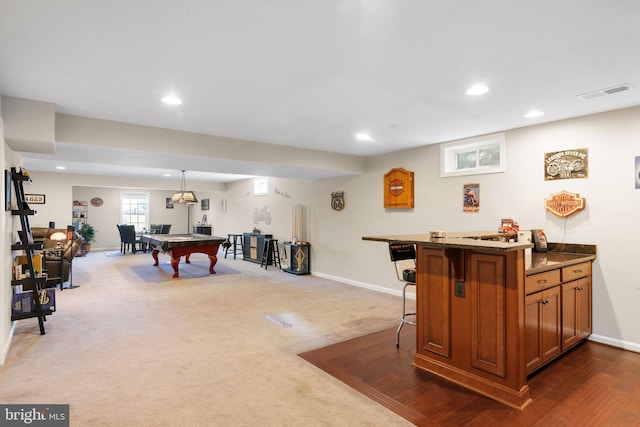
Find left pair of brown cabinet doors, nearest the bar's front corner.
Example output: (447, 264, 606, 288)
(524, 286, 561, 372)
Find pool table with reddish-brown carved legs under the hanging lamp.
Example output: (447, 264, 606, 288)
(141, 234, 225, 278)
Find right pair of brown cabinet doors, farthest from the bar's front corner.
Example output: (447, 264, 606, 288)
(562, 277, 592, 350)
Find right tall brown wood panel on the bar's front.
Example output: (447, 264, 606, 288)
(468, 253, 506, 377)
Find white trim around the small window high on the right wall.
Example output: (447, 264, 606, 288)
(440, 132, 507, 178)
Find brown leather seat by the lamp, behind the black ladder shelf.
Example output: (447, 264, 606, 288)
(31, 227, 84, 289)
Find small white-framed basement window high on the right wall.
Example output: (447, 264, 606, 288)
(440, 133, 506, 178)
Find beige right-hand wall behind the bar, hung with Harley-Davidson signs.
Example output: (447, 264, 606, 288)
(311, 107, 640, 351)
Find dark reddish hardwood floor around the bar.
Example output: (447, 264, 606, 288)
(300, 327, 640, 427)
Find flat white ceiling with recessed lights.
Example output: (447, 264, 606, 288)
(0, 0, 640, 181)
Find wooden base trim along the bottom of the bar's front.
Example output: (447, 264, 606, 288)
(413, 354, 531, 410)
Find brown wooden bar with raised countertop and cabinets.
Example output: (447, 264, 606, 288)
(362, 231, 596, 409)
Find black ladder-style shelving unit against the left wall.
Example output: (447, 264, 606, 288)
(11, 167, 53, 335)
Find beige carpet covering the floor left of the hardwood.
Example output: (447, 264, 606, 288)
(0, 249, 411, 426)
